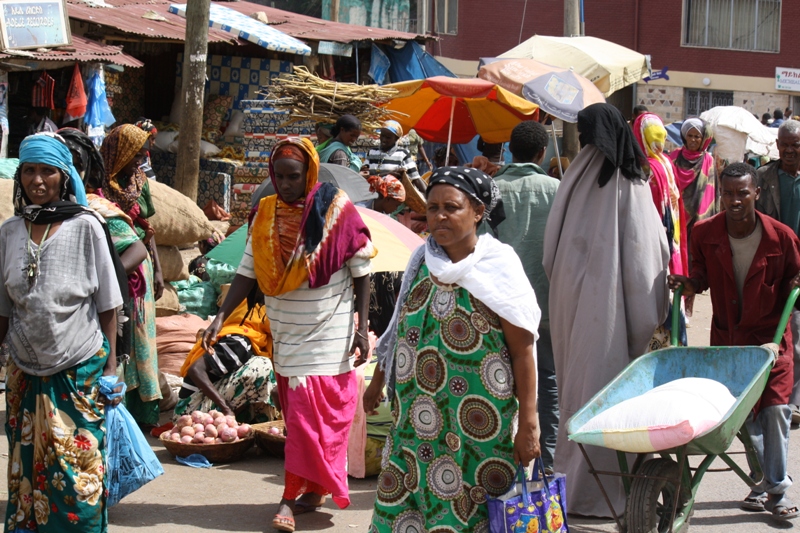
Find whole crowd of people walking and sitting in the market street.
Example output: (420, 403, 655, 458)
(0, 104, 800, 533)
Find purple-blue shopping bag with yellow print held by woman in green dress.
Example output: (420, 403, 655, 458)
(486, 459, 569, 533)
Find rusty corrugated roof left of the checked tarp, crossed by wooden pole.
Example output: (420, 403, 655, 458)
(67, 0, 238, 43)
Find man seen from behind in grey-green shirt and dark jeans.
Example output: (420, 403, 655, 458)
(494, 121, 559, 468)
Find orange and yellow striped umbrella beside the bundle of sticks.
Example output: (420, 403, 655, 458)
(385, 76, 539, 144)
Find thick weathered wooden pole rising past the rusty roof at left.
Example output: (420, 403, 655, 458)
(175, 0, 211, 200)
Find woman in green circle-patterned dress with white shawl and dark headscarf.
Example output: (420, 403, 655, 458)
(364, 167, 541, 533)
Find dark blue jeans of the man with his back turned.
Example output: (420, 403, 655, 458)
(536, 327, 558, 468)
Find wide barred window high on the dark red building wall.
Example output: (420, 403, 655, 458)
(683, 0, 781, 52)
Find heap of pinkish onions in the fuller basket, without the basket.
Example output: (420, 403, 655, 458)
(161, 410, 252, 444)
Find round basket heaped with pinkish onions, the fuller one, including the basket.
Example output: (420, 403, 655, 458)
(159, 410, 255, 463)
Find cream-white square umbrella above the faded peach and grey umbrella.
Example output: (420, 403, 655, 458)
(498, 35, 650, 96)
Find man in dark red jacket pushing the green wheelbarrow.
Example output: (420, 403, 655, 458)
(669, 163, 800, 520)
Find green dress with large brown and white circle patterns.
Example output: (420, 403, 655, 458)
(370, 263, 519, 533)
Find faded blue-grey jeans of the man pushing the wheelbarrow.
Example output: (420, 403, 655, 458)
(745, 405, 792, 494)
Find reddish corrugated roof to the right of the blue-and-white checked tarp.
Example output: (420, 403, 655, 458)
(215, 1, 425, 43)
